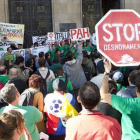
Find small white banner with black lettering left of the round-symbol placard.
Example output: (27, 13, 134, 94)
(32, 35, 50, 46)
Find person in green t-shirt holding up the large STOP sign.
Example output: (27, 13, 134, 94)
(100, 61, 140, 140)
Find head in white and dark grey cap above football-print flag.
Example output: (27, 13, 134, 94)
(52, 78, 67, 92)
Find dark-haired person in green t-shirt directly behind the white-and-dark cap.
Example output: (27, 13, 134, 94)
(48, 67, 74, 94)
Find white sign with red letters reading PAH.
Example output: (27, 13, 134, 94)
(70, 28, 90, 41)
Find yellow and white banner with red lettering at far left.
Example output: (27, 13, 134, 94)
(0, 23, 24, 47)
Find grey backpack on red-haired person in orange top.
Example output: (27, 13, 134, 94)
(19, 89, 39, 106)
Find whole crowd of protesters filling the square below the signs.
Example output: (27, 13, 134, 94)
(0, 40, 140, 140)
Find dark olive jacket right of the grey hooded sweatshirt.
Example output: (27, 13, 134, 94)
(82, 57, 95, 79)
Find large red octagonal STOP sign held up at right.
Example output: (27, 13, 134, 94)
(96, 10, 140, 66)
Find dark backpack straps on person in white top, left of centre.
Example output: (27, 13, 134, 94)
(35, 69, 50, 97)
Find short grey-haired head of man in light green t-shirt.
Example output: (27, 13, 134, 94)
(0, 84, 20, 104)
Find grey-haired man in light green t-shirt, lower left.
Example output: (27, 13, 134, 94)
(0, 84, 43, 140)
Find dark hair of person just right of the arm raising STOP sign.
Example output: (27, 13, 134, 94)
(108, 80, 117, 94)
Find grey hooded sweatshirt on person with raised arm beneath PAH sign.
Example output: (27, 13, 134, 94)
(63, 46, 87, 89)
